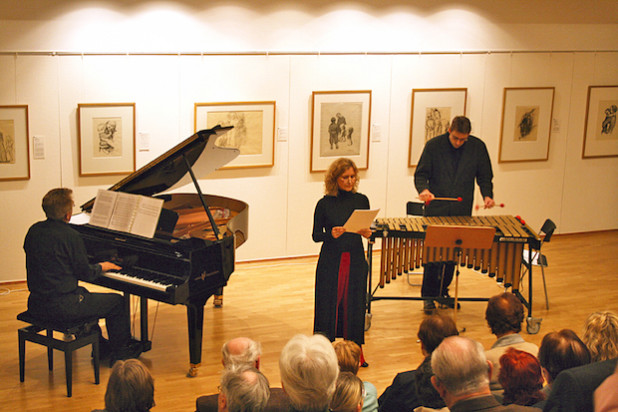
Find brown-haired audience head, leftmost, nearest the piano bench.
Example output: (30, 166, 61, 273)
(105, 359, 155, 412)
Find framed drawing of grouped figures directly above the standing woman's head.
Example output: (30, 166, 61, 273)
(310, 90, 371, 172)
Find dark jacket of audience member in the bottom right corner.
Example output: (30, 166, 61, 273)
(543, 358, 618, 412)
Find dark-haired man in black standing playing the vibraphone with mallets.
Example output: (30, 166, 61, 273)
(414, 116, 495, 313)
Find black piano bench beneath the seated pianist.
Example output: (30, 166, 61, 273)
(17, 311, 100, 398)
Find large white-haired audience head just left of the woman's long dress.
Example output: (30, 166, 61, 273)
(279, 335, 339, 411)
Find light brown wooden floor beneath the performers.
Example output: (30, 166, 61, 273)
(0, 231, 618, 411)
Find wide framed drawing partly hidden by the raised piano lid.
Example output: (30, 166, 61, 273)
(195, 101, 275, 169)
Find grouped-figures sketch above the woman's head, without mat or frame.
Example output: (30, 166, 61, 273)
(319, 102, 363, 157)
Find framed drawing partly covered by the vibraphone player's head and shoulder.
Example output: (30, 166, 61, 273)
(408, 88, 468, 167)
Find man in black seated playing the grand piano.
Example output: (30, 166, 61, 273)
(24, 188, 142, 363)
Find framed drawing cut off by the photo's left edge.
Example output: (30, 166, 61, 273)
(0, 106, 30, 181)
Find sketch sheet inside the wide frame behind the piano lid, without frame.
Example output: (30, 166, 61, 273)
(206, 110, 264, 155)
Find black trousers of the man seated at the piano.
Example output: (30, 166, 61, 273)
(28, 287, 131, 350)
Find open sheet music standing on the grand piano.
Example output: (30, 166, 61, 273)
(90, 189, 163, 238)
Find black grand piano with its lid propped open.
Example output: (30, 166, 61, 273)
(71, 126, 249, 376)
